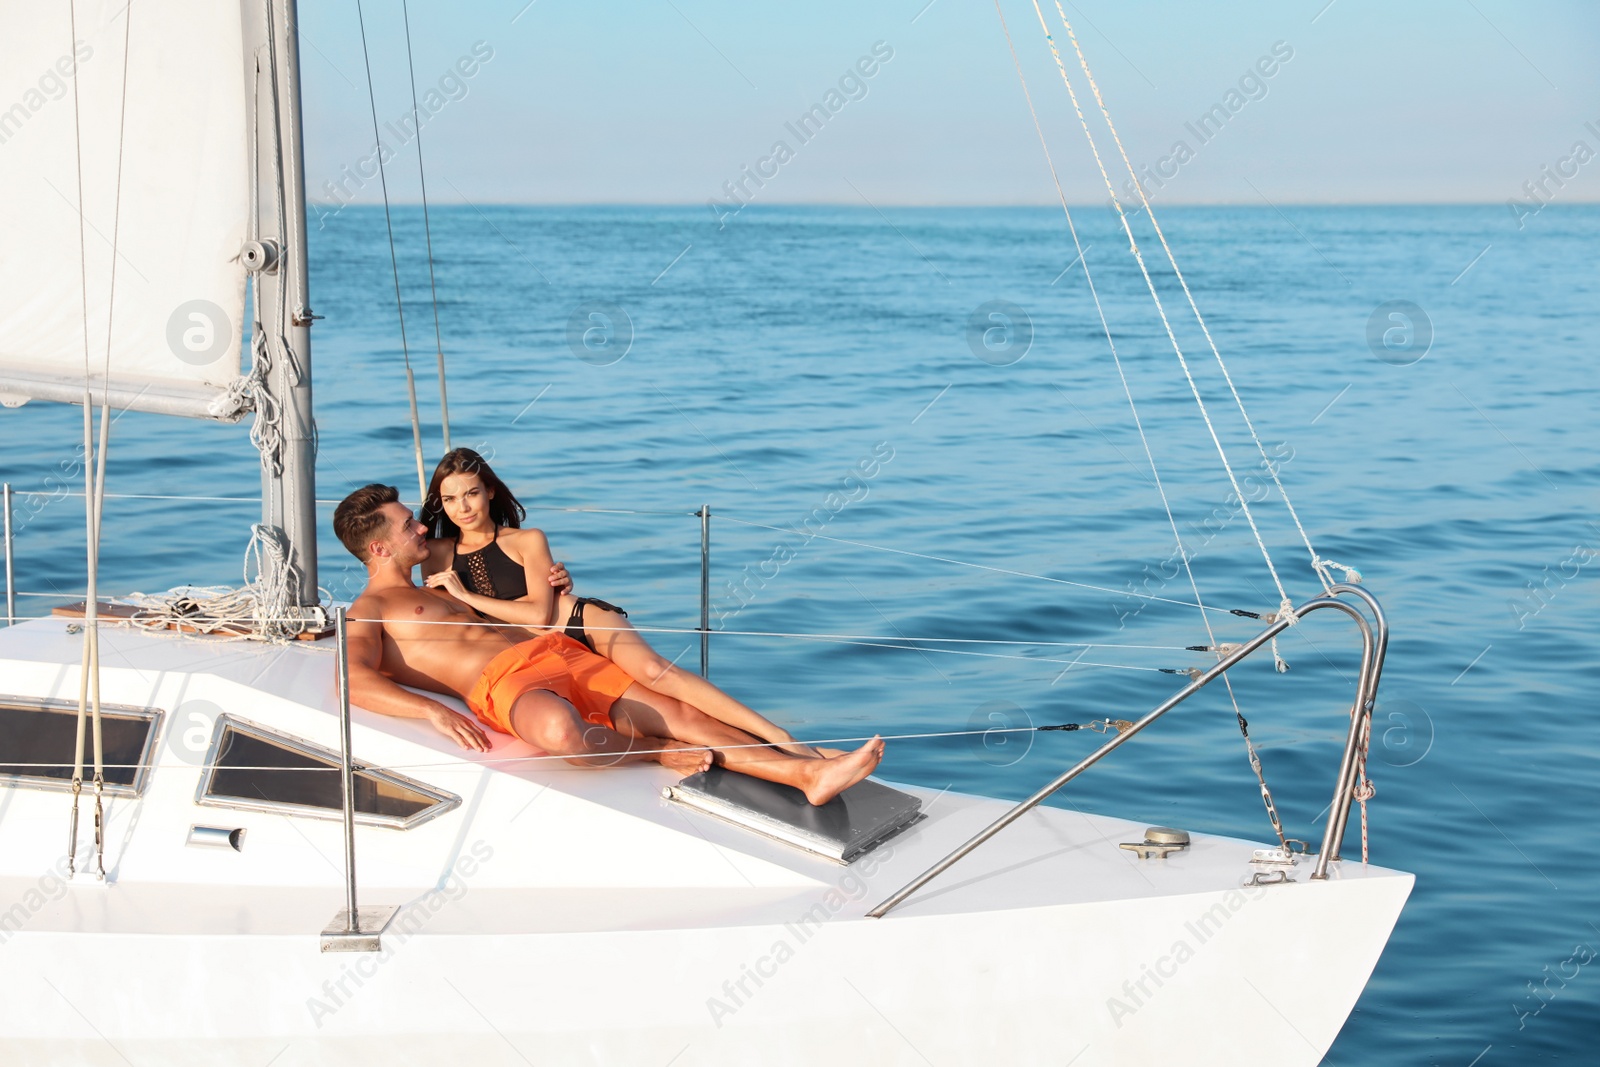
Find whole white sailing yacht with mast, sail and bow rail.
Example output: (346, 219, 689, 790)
(0, 0, 1413, 1065)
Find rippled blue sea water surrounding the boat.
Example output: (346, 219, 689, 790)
(0, 205, 1600, 1067)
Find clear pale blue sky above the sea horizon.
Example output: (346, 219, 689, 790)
(301, 0, 1600, 205)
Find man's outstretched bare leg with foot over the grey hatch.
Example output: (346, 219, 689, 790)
(611, 683, 883, 805)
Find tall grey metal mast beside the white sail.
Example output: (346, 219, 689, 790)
(240, 0, 318, 608)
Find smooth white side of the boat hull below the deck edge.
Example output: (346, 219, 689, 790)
(0, 878, 1411, 1067)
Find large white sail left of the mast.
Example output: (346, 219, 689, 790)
(0, 0, 253, 419)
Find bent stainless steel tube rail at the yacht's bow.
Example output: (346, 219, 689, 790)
(867, 585, 1389, 918)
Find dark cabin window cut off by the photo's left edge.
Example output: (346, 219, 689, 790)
(0, 697, 162, 797)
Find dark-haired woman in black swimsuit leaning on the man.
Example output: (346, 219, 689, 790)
(421, 448, 837, 757)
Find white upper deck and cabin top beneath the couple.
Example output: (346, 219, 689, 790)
(0, 619, 1410, 934)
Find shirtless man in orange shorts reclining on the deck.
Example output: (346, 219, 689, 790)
(333, 485, 883, 805)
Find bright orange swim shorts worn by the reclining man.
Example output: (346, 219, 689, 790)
(467, 633, 634, 734)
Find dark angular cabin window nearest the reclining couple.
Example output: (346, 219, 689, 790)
(195, 715, 461, 830)
